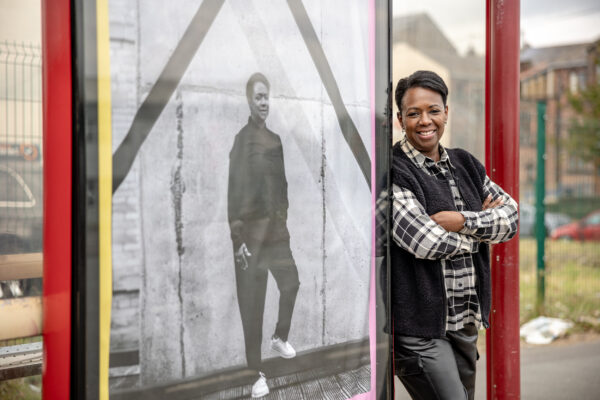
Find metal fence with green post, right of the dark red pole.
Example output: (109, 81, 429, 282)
(520, 96, 600, 330)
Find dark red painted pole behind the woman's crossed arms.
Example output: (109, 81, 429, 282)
(486, 0, 521, 399)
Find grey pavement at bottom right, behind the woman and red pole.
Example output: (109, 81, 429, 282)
(395, 336, 600, 400)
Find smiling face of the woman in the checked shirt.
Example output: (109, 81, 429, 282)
(398, 87, 448, 161)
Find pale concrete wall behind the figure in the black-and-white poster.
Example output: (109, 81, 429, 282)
(110, 0, 372, 387)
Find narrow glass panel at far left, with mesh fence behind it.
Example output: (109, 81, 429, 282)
(0, 0, 43, 399)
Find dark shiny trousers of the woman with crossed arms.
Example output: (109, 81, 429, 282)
(394, 324, 477, 400)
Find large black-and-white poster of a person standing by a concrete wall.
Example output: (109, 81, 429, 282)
(101, 0, 374, 399)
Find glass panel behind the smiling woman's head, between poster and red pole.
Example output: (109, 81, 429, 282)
(393, 0, 485, 162)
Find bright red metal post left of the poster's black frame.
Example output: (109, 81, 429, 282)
(42, 0, 72, 400)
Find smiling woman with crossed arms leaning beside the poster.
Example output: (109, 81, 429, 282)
(391, 71, 518, 400)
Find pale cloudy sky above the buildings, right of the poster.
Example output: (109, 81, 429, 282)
(393, 0, 600, 54)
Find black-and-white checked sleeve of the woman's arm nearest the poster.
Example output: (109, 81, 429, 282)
(392, 185, 479, 260)
